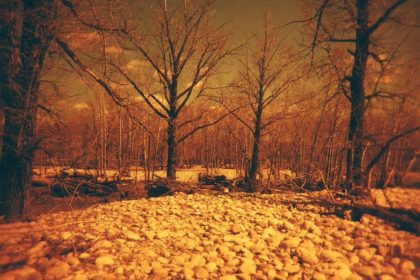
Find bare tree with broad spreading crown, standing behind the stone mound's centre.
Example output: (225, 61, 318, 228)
(57, 0, 237, 179)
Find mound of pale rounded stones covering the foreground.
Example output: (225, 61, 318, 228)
(0, 193, 420, 280)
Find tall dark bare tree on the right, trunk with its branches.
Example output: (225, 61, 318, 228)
(304, 0, 416, 185)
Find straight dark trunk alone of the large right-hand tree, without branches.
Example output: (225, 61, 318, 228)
(347, 0, 369, 188)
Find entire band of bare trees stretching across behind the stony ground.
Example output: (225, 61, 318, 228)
(0, 0, 420, 220)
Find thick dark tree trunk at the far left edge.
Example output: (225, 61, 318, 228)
(0, 0, 53, 221)
